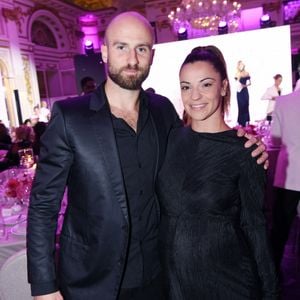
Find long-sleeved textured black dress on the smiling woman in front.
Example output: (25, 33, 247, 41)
(158, 128, 277, 300)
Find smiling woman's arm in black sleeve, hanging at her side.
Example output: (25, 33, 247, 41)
(239, 155, 279, 299)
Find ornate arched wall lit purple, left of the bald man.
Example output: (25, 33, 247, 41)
(0, 0, 81, 126)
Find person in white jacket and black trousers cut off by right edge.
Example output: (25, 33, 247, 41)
(271, 90, 300, 269)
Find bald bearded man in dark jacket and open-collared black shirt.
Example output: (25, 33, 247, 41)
(27, 12, 266, 300)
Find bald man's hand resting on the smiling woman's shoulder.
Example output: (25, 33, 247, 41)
(237, 127, 269, 170)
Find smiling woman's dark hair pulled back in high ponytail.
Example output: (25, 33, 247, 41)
(180, 45, 230, 113)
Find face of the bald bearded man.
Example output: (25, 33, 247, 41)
(102, 14, 153, 90)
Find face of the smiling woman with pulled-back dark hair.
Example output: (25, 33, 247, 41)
(179, 61, 228, 123)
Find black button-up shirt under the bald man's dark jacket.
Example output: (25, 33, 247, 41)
(112, 97, 160, 288)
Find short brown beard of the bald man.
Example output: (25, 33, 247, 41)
(108, 63, 150, 90)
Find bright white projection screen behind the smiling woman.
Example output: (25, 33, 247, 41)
(143, 25, 292, 126)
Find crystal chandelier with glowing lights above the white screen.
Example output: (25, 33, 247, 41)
(168, 0, 241, 37)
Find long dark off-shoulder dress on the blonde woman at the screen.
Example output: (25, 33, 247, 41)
(236, 76, 250, 126)
